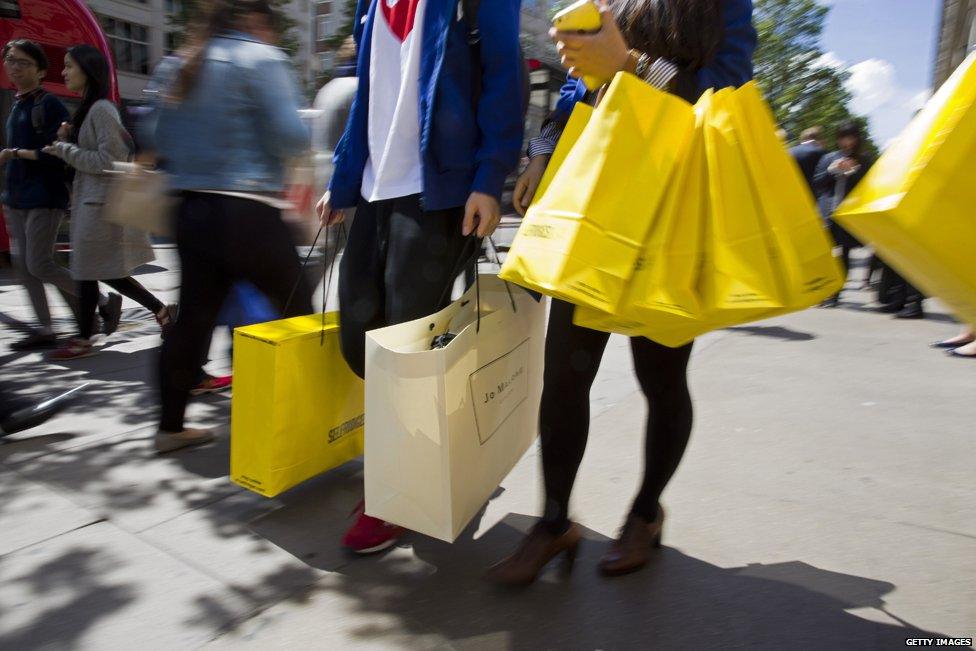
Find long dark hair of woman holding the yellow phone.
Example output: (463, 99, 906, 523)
(610, 0, 724, 71)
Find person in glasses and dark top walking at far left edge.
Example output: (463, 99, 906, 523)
(0, 39, 122, 351)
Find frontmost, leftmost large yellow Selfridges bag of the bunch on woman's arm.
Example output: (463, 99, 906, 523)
(501, 73, 694, 312)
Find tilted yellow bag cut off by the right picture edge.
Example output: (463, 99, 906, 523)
(835, 54, 976, 323)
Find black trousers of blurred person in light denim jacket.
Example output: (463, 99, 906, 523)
(159, 192, 313, 432)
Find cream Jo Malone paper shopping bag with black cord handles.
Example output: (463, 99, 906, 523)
(365, 275, 546, 542)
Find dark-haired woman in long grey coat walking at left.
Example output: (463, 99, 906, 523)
(44, 45, 172, 361)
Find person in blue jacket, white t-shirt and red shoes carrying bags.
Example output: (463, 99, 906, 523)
(317, 0, 524, 553)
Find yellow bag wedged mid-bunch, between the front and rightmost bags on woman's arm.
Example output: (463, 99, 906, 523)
(573, 92, 712, 346)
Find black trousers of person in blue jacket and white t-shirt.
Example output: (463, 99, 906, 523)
(339, 195, 472, 377)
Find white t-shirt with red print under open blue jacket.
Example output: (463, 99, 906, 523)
(362, 0, 427, 202)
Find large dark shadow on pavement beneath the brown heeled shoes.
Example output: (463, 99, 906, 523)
(302, 514, 948, 649)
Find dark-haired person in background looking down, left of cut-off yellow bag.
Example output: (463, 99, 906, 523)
(813, 122, 874, 307)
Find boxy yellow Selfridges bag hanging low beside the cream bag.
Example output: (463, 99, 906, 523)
(231, 312, 365, 497)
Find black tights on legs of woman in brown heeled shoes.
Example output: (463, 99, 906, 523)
(540, 300, 692, 533)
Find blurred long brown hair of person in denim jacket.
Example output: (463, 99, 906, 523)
(167, 0, 275, 102)
